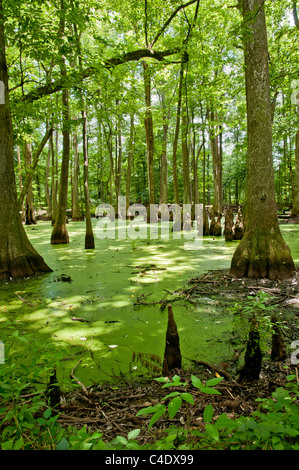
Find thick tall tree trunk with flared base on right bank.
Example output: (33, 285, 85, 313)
(231, 0, 294, 279)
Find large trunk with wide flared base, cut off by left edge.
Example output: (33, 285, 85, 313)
(0, 0, 52, 280)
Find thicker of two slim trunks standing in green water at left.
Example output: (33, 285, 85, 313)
(51, 0, 70, 245)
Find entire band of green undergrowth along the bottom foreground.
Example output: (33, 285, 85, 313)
(0, 322, 299, 450)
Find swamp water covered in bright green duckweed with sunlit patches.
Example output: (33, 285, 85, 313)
(0, 219, 299, 386)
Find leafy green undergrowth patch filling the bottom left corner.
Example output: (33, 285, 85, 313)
(0, 321, 68, 450)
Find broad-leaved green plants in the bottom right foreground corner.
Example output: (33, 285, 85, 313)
(138, 375, 299, 450)
